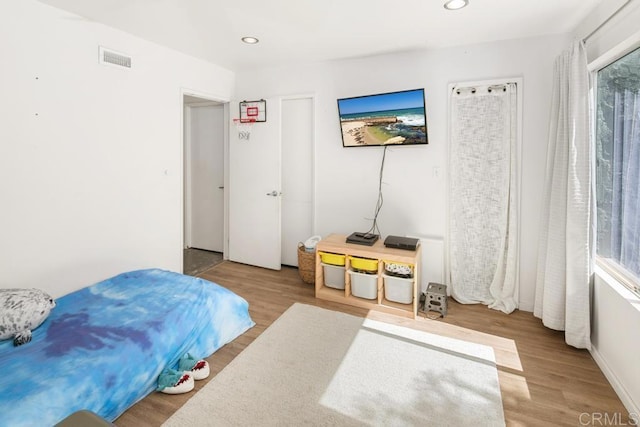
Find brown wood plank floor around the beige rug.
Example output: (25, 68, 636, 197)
(115, 261, 633, 427)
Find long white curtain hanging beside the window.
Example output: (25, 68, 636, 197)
(534, 42, 592, 349)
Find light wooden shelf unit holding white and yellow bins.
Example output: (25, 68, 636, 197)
(315, 234, 420, 319)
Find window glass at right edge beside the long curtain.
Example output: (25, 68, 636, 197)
(596, 49, 640, 292)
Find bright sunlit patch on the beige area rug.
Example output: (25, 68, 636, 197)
(319, 319, 504, 425)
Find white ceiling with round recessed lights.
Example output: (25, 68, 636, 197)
(39, 0, 603, 70)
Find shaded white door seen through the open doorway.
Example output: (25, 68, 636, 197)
(187, 105, 224, 252)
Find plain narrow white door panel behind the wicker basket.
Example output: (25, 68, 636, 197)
(282, 97, 314, 266)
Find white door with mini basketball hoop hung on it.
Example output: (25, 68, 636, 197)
(229, 98, 282, 270)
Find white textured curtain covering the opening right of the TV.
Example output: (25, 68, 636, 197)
(448, 83, 519, 313)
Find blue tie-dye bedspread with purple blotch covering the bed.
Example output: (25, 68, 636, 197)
(0, 269, 254, 426)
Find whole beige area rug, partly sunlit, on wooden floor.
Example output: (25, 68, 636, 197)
(163, 304, 504, 426)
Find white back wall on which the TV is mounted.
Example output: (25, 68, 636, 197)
(237, 35, 570, 310)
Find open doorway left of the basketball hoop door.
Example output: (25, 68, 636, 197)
(183, 94, 227, 275)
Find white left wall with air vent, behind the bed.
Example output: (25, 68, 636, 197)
(0, 0, 234, 296)
